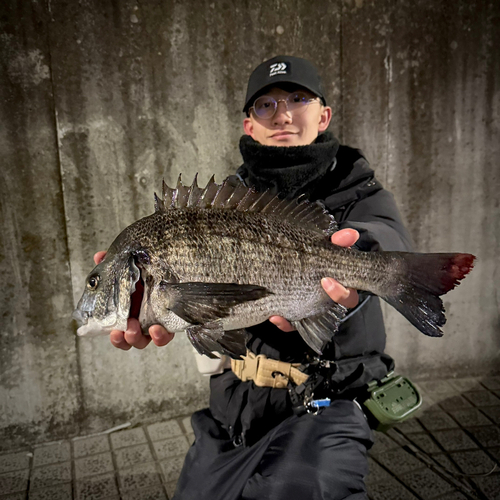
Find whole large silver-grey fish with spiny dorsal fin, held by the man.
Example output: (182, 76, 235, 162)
(75, 176, 474, 357)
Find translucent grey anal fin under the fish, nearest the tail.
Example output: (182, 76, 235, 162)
(292, 301, 347, 354)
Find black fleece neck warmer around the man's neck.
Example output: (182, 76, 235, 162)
(238, 132, 339, 197)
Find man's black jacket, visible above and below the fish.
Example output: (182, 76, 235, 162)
(210, 146, 412, 442)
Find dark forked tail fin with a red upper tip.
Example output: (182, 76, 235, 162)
(379, 252, 475, 337)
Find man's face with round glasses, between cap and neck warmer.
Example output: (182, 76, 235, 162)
(243, 87, 332, 146)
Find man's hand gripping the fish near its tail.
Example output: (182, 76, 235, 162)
(269, 229, 359, 332)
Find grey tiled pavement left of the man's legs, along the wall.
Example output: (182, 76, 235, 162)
(0, 417, 193, 500)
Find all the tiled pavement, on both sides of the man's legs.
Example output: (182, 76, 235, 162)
(0, 377, 500, 500)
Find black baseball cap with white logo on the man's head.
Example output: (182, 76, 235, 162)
(243, 56, 326, 113)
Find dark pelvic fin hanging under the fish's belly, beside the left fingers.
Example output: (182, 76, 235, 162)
(186, 321, 248, 359)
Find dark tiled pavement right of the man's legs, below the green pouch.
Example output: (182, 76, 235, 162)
(367, 377, 500, 500)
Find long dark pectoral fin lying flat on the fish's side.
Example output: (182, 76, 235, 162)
(161, 282, 272, 324)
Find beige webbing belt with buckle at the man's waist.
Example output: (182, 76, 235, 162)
(231, 351, 309, 389)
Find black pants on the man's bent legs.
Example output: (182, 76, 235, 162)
(174, 400, 373, 500)
